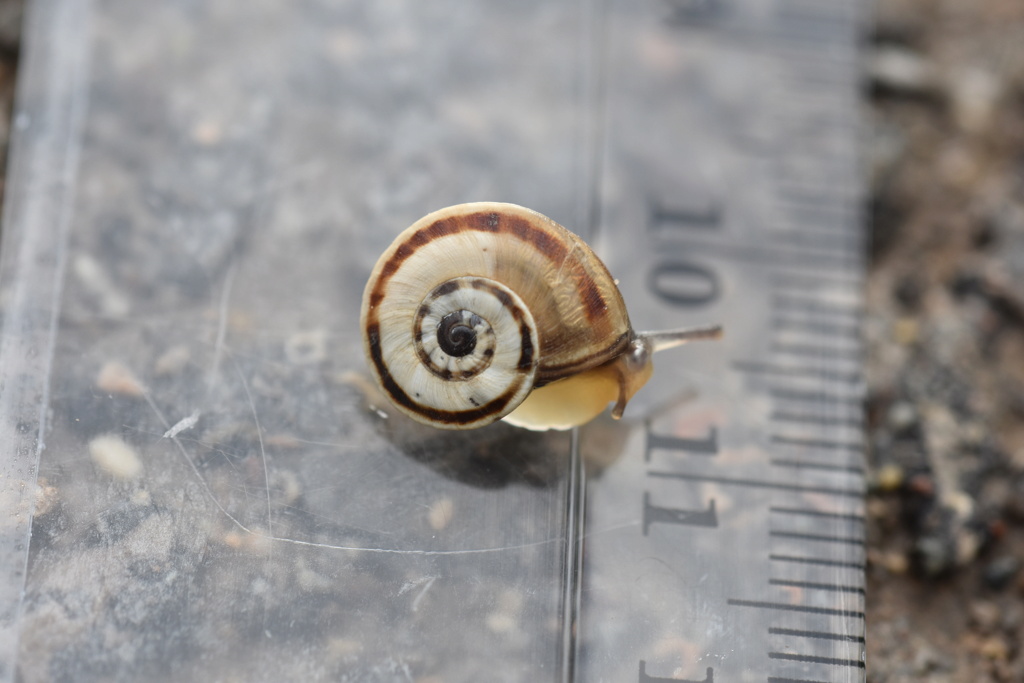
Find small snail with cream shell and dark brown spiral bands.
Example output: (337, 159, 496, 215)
(360, 202, 721, 430)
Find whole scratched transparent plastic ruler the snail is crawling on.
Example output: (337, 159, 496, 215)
(0, 0, 863, 683)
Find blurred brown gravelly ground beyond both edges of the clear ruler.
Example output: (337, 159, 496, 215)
(0, 0, 1024, 683)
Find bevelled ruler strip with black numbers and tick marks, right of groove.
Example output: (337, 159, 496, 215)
(578, 0, 865, 683)
